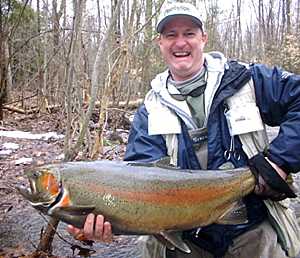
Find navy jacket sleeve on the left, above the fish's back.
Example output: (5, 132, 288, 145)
(124, 105, 167, 162)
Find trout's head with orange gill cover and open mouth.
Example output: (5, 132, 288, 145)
(17, 166, 61, 213)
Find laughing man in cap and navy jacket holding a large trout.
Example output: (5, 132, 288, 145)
(68, 3, 300, 258)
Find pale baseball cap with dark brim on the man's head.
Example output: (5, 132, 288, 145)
(156, 3, 204, 33)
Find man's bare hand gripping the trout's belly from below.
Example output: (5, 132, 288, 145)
(67, 213, 113, 243)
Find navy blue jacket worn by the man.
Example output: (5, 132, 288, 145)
(125, 61, 300, 256)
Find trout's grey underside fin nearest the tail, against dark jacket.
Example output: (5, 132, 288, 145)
(216, 200, 248, 225)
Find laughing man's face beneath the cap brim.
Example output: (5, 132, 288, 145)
(158, 16, 207, 81)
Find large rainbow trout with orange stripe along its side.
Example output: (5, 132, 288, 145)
(18, 161, 255, 252)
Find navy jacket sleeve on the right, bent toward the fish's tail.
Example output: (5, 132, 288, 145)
(252, 65, 300, 173)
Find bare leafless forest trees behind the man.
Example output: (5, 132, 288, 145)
(0, 0, 300, 160)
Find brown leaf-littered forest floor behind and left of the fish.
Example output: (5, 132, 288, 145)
(0, 109, 136, 257)
